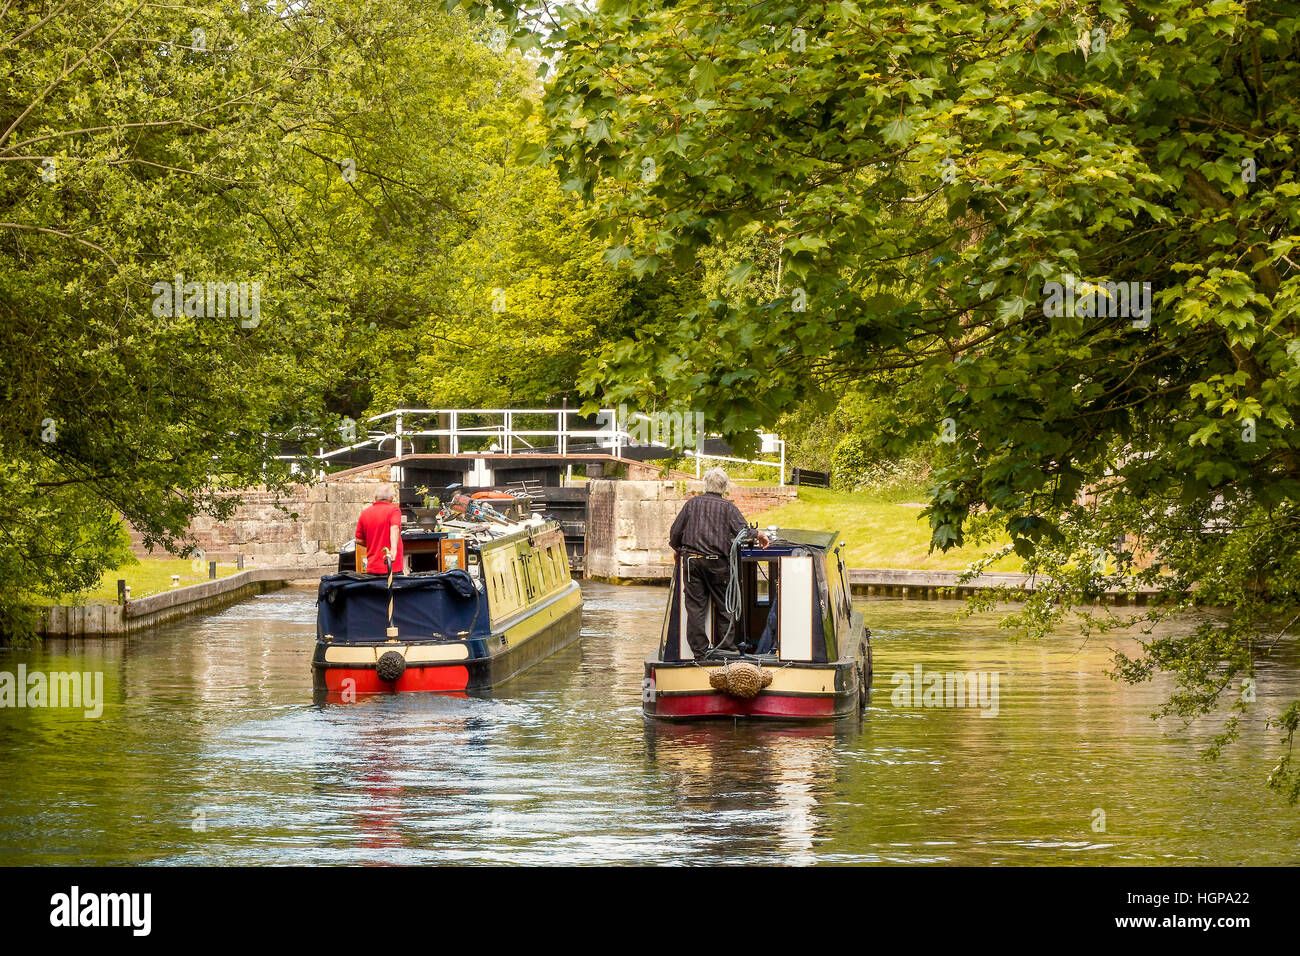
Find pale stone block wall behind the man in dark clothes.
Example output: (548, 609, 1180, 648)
(586, 480, 798, 581)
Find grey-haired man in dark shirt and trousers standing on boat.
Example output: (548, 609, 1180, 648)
(668, 468, 768, 658)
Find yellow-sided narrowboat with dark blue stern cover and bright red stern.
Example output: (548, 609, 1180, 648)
(312, 509, 582, 701)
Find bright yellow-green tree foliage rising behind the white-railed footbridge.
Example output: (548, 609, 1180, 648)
(274, 3, 644, 416)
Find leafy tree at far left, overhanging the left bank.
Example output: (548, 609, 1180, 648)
(0, 0, 361, 635)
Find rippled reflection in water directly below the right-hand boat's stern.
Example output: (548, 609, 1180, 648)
(646, 719, 859, 865)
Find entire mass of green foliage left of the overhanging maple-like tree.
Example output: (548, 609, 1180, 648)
(0, 0, 647, 636)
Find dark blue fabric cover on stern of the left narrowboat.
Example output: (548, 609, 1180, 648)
(316, 570, 488, 643)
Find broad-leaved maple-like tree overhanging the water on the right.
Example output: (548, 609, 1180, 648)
(473, 0, 1300, 799)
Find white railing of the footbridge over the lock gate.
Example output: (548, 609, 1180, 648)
(276, 408, 785, 485)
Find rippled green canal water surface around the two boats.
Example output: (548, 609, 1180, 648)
(0, 585, 1300, 865)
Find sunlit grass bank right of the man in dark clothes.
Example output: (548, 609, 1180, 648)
(751, 486, 1021, 571)
